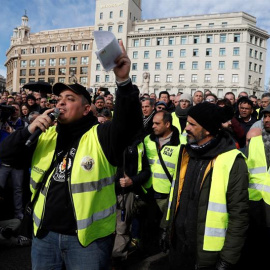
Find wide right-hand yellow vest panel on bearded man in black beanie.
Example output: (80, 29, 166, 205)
(203, 149, 241, 251)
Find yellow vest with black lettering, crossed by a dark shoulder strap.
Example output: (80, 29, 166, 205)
(144, 135, 180, 194)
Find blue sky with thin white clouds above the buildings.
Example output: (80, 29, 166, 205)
(0, 0, 270, 83)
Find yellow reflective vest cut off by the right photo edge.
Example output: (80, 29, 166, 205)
(247, 136, 270, 205)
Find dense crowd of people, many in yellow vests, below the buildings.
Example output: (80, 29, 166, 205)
(0, 44, 270, 270)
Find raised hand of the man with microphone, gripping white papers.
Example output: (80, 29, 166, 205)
(113, 40, 131, 82)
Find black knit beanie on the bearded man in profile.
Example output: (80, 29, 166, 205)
(188, 102, 223, 136)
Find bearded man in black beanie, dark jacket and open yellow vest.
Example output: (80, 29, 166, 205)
(167, 102, 248, 270)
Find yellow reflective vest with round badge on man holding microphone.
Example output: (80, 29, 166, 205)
(30, 125, 116, 247)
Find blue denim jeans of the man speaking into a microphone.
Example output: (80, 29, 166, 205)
(31, 232, 113, 270)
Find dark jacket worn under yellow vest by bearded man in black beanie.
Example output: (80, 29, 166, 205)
(170, 133, 248, 270)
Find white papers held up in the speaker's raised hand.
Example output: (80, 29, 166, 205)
(94, 31, 122, 71)
